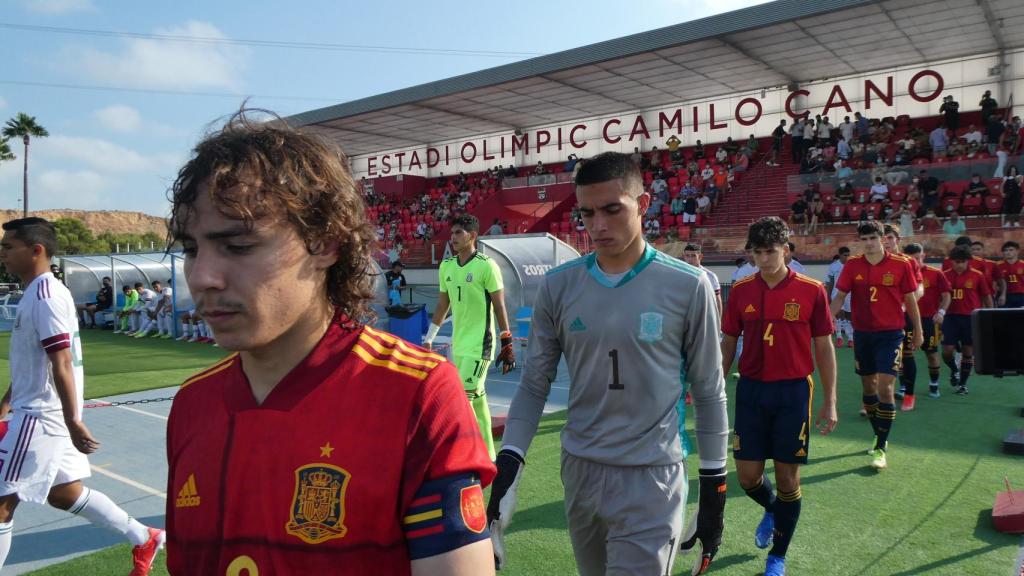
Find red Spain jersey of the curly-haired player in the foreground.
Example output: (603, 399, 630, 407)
(167, 320, 495, 576)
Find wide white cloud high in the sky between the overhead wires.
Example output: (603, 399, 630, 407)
(62, 22, 250, 90)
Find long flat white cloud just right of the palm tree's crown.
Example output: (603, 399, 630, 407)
(45, 135, 178, 172)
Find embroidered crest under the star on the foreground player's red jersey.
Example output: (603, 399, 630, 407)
(285, 463, 351, 544)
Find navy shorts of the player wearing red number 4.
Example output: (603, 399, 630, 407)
(732, 375, 811, 464)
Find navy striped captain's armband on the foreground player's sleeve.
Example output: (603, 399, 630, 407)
(401, 475, 489, 560)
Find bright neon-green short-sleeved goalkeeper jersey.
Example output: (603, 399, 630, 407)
(438, 252, 504, 360)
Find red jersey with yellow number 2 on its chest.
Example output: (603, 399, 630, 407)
(836, 252, 918, 332)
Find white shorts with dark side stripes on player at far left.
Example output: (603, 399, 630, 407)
(0, 412, 91, 504)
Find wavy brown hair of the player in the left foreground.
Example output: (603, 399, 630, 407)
(169, 108, 377, 322)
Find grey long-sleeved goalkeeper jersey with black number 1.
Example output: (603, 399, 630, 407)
(504, 246, 729, 466)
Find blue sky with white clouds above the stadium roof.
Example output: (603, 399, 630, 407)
(0, 0, 764, 216)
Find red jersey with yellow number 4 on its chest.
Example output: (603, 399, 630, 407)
(722, 271, 834, 381)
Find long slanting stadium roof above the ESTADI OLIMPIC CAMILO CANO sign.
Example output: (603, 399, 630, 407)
(287, 0, 1024, 156)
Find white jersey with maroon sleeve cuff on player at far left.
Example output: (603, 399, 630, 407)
(10, 273, 85, 428)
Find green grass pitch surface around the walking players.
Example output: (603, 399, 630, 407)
(9, 332, 1024, 576)
